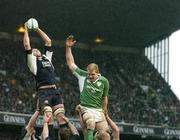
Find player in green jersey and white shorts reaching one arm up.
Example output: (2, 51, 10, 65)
(66, 35, 110, 140)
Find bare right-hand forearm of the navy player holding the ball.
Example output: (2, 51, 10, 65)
(36, 27, 52, 47)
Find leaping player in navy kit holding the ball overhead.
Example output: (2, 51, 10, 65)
(23, 20, 75, 139)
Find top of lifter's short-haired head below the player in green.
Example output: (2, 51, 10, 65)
(95, 130, 110, 140)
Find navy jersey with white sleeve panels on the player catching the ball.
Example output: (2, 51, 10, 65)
(27, 47, 56, 89)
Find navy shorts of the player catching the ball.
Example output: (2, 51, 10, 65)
(38, 88, 63, 109)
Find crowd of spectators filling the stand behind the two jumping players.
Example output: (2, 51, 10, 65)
(0, 40, 180, 127)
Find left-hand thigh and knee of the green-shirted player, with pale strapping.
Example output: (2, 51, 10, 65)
(83, 113, 95, 128)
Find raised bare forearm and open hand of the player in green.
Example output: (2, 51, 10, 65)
(66, 35, 77, 72)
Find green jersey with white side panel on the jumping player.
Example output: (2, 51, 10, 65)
(73, 68, 109, 109)
